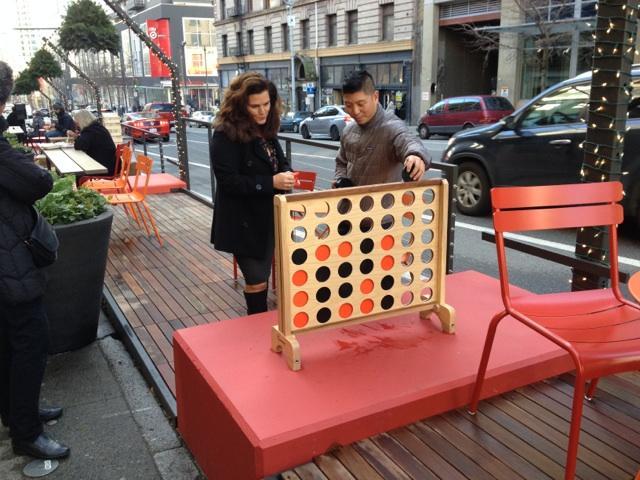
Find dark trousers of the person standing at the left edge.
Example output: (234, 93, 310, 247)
(0, 297, 49, 440)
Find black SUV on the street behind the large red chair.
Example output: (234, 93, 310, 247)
(443, 69, 640, 230)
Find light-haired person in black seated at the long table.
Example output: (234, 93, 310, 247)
(66, 110, 116, 176)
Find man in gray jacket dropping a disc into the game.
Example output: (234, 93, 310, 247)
(334, 71, 431, 187)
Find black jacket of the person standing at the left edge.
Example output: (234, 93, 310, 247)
(0, 136, 53, 305)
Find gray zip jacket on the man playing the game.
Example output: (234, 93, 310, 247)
(335, 105, 431, 185)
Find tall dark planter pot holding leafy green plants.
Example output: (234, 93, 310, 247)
(44, 210, 113, 353)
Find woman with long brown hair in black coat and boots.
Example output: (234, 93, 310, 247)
(210, 72, 294, 314)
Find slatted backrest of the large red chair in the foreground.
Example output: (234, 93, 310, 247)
(491, 182, 624, 232)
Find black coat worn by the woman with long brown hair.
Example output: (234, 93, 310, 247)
(210, 130, 291, 258)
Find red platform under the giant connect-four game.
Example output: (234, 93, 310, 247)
(174, 272, 571, 480)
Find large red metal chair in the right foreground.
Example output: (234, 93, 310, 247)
(469, 182, 640, 480)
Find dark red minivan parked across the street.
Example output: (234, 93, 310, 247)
(418, 95, 513, 139)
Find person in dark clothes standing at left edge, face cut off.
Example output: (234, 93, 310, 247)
(0, 62, 69, 459)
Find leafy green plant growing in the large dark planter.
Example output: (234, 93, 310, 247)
(36, 175, 107, 225)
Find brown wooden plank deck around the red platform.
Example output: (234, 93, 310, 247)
(105, 194, 640, 480)
